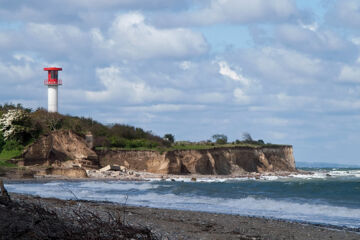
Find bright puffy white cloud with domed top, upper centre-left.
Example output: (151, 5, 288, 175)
(92, 13, 208, 59)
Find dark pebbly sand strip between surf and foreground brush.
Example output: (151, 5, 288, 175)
(5, 194, 360, 240)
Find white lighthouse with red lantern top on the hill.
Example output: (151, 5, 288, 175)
(44, 67, 62, 112)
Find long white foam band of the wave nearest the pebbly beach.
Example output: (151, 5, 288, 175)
(89, 192, 360, 228)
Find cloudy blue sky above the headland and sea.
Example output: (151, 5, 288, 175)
(0, 0, 360, 164)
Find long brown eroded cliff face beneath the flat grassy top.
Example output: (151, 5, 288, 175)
(97, 146, 296, 175)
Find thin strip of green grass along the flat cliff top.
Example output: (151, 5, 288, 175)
(96, 143, 286, 152)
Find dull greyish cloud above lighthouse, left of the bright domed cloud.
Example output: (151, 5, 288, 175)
(0, 22, 91, 60)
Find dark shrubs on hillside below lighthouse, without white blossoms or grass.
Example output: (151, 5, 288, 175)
(0, 104, 169, 148)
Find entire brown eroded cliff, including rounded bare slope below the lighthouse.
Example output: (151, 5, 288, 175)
(18, 130, 296, 175)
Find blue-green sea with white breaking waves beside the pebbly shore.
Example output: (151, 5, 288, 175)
(6, 169, 360, 230)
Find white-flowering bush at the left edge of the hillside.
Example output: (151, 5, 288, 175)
(0, 109, 31, 142)
